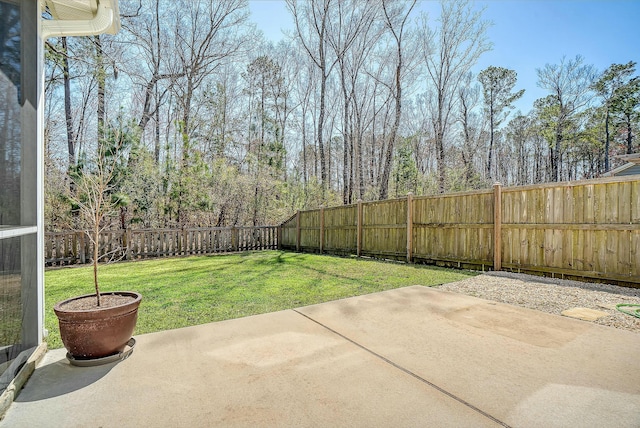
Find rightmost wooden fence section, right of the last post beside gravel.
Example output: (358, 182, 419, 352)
(502, 179, 640, 283)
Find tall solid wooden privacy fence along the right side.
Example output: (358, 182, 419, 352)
(280, 176, 640, 287)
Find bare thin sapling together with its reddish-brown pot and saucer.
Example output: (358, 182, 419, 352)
(54, 122, 142, 365)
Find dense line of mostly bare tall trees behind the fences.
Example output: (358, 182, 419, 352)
(45, 0, 640, 229)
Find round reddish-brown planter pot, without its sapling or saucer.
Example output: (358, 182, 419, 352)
(53, 291, 142, 359)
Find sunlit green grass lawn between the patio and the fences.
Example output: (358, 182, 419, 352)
(45, 251, 475, 348)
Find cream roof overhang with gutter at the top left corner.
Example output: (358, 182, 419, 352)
(42, 0, 120, 40)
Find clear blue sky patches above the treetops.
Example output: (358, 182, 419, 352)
(249, 0, 640, 112)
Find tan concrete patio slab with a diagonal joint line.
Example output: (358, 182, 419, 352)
(0, 286, 640, 427)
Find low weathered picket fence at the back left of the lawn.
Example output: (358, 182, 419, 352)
(45, 226, 278, 266)
